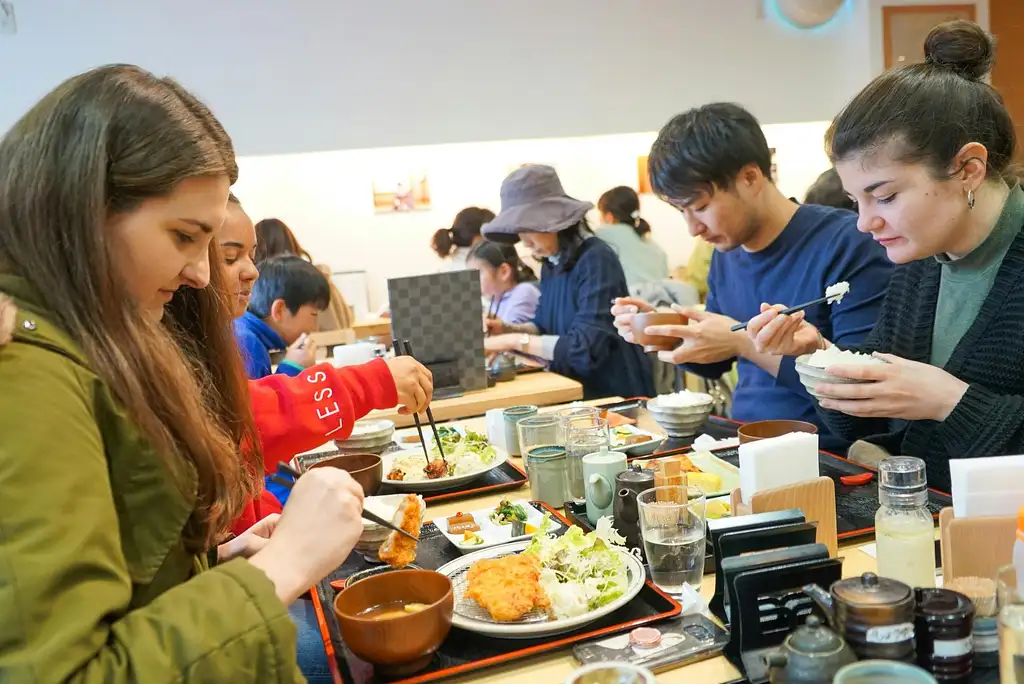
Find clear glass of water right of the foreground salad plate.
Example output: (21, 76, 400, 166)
(637, 484, 706, 596)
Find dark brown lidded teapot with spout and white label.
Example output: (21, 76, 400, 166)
(804, 572, 916, 662)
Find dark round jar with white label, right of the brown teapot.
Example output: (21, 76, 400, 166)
(913, 587, 975, 684)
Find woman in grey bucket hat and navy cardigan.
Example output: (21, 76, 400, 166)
(483, 165, 654, 399)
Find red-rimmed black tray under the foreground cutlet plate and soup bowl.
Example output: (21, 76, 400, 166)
(311, 502, 682, 684)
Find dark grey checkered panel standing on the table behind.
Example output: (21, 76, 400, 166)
(387, 270, 487, 390)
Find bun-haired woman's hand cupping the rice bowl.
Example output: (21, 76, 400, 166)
(814, 353, 968, 422)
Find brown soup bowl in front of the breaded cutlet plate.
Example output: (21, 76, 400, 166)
(334, 570, 455, 679)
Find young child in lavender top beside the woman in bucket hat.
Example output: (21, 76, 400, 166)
(466, 240, 541, 326)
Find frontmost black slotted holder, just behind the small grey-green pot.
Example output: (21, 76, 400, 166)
(722, 544, 843, 684)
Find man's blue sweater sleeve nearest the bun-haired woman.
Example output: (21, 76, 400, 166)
(775, 228, 893, 391)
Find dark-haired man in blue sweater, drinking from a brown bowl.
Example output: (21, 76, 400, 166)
(612, 103, 892, 453)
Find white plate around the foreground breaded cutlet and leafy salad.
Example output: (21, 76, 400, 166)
(437, 541, 647, 639)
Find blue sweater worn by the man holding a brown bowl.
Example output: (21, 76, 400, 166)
(687, 205, 893, 453)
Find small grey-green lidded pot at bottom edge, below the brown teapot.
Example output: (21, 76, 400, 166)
(765, 615, 857, 684)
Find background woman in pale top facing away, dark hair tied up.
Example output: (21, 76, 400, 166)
(597, 185, 669, 290)
